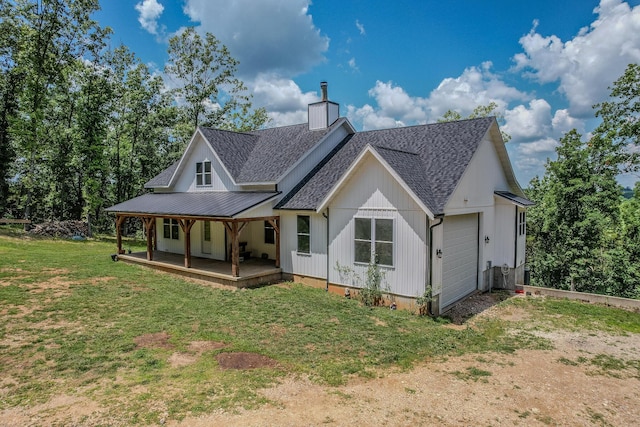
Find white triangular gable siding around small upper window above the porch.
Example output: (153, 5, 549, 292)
(172, 134, 240, 192)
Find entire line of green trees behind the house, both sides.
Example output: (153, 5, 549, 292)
(0, 0, 640, 298)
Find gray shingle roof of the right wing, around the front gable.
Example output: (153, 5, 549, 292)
(276, 117, 495, 215)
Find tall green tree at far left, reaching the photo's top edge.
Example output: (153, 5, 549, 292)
(10, 0, 100, 218)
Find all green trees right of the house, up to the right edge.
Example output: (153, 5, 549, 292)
(526, 64, 640, 298)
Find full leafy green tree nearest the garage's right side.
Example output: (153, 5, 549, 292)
(528, 130, 634, 295)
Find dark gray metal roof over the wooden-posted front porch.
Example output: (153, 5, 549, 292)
(105, 191, 280, 218)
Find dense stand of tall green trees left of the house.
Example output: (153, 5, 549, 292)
(0, 0, 268, 230)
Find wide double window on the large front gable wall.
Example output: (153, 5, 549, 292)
(354, 218, 393, 265)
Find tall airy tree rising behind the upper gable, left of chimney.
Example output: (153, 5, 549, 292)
(165, 27, 267, 137)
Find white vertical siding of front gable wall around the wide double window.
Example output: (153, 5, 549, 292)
(329, 155, 428, 297)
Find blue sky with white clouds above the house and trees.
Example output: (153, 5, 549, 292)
(95, 0, 640, 186)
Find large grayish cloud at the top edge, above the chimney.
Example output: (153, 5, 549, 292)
(184, 0, 329, 80)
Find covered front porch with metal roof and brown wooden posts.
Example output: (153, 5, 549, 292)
(107, 192, 281, 287)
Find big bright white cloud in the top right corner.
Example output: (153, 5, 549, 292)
(514, 0, 640, 117)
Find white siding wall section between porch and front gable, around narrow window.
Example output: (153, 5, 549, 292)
(279, 211, 327, 279)
